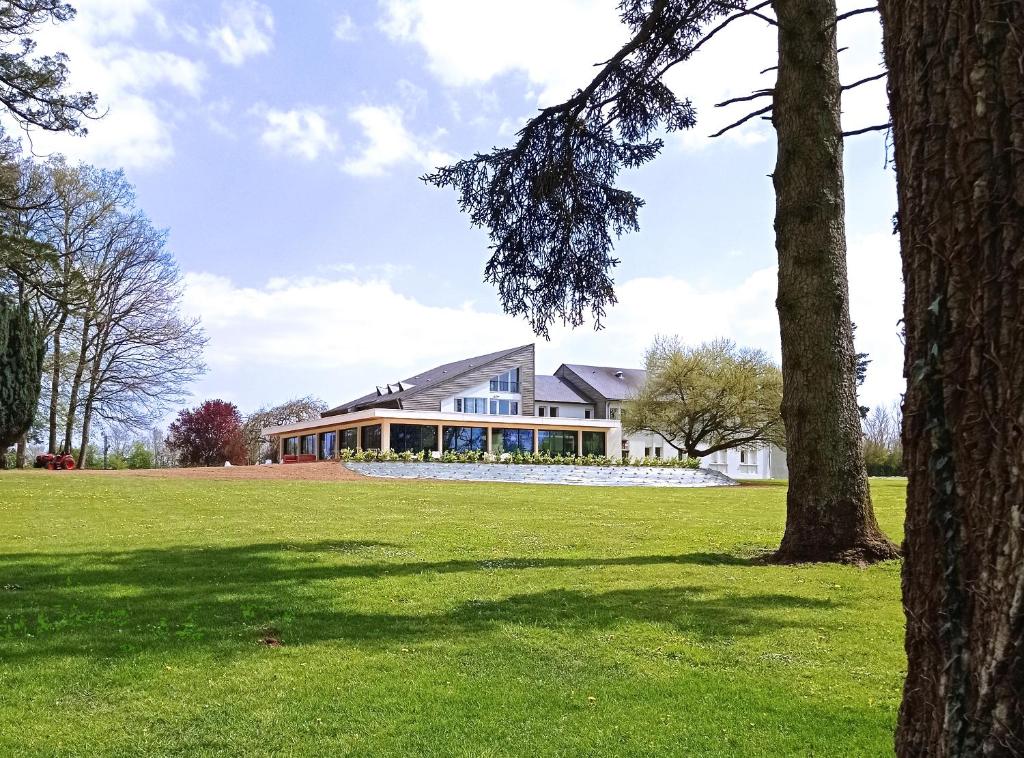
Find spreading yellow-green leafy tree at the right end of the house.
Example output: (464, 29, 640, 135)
(623, 337, 785, 458)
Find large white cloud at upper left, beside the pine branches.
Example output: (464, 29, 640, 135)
(18, 0, 206, 168)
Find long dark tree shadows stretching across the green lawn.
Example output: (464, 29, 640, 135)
(0, 542, 835, 662)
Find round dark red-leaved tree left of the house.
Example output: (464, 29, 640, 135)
(167, 401, 247, 466)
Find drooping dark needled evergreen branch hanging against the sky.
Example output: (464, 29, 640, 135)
(423, 0, 745, 336)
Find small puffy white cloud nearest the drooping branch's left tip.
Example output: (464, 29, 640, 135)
(342, 106, 452, 176)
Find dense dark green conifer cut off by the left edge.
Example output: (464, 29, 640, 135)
(0, 297, 45, 458)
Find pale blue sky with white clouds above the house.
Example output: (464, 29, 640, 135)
(24, 0, 904, 413)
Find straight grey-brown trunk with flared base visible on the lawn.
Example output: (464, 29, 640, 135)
(773, 0, 897, 562)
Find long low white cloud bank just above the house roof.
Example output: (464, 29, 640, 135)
(185, 236, 903, 406)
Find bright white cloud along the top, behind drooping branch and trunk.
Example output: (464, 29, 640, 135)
(381, 0, 886, 149)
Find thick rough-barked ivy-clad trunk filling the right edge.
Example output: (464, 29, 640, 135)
(881, 0, 1024, 756)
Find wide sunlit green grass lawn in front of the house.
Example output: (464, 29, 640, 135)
(0, 472, 905, 756)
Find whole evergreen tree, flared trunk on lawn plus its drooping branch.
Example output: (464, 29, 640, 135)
(424, 0, 897, 561)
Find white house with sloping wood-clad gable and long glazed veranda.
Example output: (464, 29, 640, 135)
(264, 344, 784, 477)
